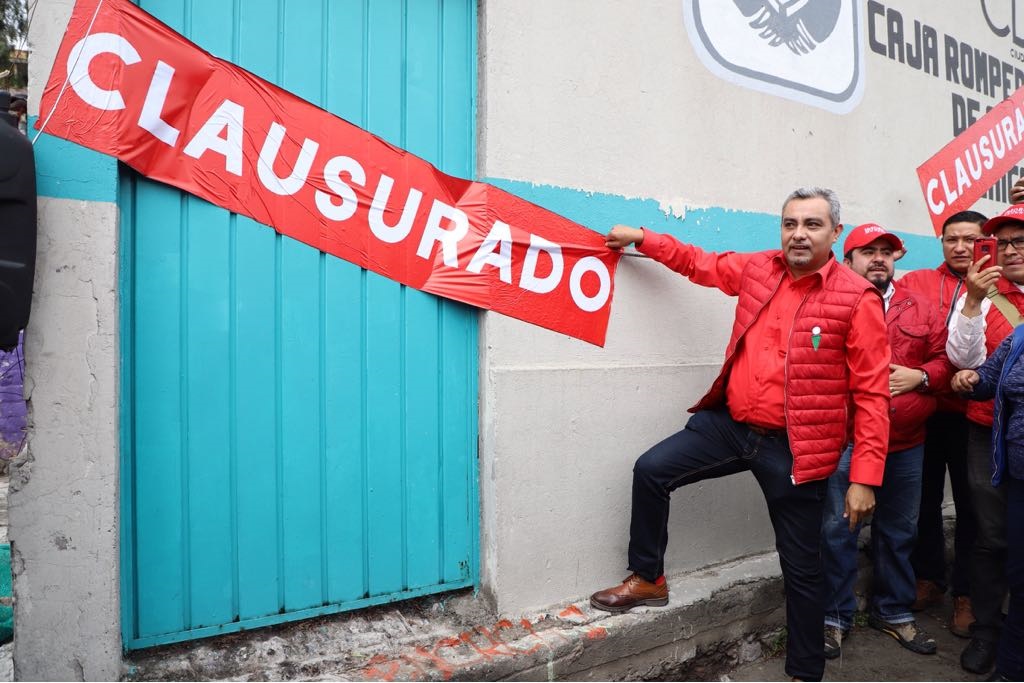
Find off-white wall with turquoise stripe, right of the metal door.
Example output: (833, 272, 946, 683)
(479, 0, 1024, 611)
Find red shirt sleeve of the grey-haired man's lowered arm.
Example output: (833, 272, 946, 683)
(846, 291, 892, 486)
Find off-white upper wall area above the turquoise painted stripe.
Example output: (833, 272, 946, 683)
(479, 0, 1024, 229)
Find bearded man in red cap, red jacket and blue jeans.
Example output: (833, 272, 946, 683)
(821, 223, 952, 658)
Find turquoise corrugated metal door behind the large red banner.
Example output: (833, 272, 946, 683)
(120, 0, 477, 648)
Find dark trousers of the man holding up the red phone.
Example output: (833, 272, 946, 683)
(968, 423, 1007, 642)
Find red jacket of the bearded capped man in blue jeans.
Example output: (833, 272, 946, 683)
(886, 281, 953, 453)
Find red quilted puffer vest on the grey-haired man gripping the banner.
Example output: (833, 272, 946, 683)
(690, 250, 888, 483)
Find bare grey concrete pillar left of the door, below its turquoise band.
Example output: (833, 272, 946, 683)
(10, 194, 121, 680)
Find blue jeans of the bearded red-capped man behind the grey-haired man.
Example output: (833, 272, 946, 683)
(821, 445, 925, 630)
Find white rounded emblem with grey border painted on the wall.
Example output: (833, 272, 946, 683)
(683, 0, 864, 114)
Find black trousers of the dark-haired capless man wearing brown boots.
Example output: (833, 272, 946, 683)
(910, 413, 977, 596)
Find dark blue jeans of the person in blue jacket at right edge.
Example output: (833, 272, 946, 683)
(995, 477, 1024, 681)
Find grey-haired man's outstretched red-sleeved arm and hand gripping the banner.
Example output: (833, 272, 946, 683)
(606, 225, 751, 296)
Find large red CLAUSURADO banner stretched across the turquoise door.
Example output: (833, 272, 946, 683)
(36, 0, 618, 345)
